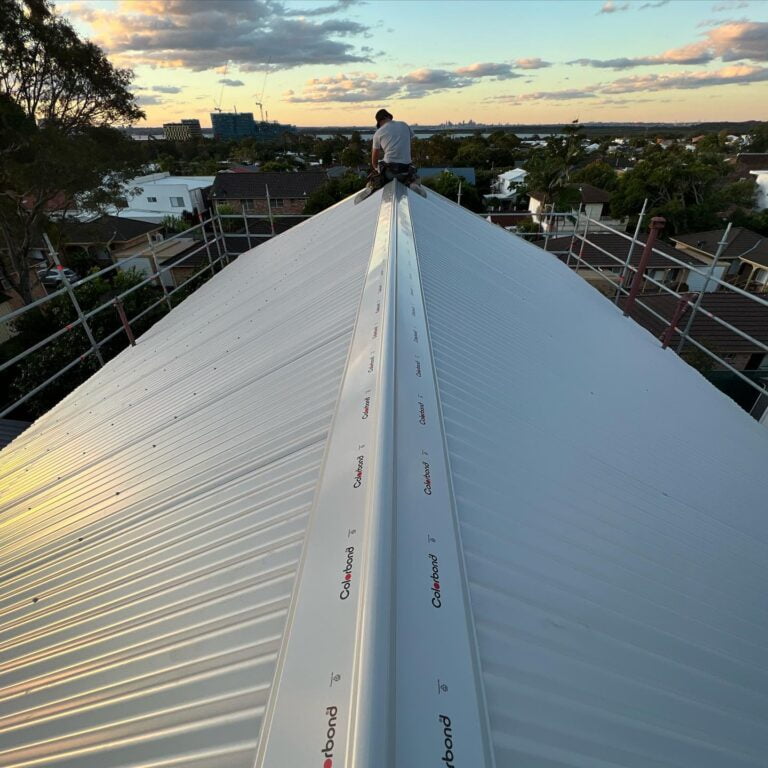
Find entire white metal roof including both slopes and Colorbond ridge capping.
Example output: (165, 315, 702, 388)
(0, 183, 768, 768)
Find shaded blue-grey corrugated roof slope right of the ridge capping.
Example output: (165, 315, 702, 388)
(411, 188, 768, 768)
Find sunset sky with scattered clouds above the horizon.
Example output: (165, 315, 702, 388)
(57, 0, 768, 127)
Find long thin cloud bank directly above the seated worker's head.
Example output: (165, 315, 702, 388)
(283, 62, 523, 104)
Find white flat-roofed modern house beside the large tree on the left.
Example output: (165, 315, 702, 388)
(112, 172, 214, 224)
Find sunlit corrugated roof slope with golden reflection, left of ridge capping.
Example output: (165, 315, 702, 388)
(0, 194, 377, 768)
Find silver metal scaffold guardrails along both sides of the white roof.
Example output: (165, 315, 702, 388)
(6, 206, 768, 418)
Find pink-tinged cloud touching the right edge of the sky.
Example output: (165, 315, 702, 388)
(568, 21, 768, 69)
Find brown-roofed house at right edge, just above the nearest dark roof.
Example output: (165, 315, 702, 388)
(671, 227, 768, 291)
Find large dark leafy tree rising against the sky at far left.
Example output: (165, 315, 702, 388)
(0, 0, 143, 303)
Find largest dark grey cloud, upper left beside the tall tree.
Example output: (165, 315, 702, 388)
(64, 0, 370, 72)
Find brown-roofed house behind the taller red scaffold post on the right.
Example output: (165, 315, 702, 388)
(547, 232, 717, 296)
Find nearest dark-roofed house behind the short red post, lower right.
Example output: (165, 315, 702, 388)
(620, 291, 768, 375)
